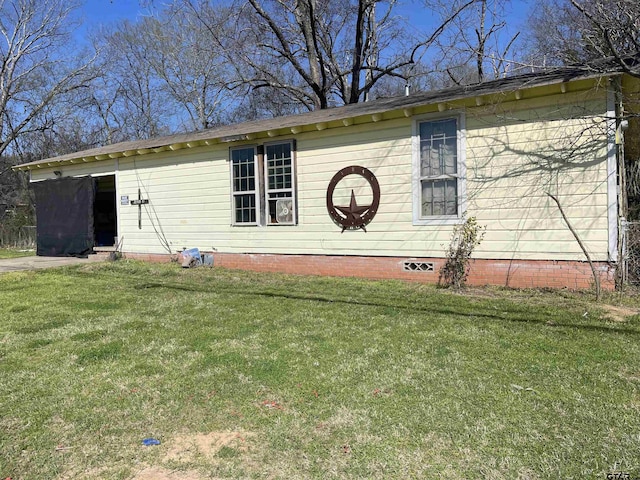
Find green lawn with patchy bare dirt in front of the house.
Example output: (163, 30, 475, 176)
(0, 261, 640, 480)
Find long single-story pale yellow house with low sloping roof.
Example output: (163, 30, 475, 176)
(11, 63, 640, 288)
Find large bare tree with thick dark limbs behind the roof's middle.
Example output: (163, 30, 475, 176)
(184, 0, 475, 110)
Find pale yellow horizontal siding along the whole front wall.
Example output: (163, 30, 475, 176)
(33, 86, 608, 260)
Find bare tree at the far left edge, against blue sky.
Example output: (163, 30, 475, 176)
(0, 0, 97, 221)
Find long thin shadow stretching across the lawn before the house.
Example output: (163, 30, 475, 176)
(126, 282, 640, 336)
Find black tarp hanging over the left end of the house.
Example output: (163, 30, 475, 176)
(33, 177, 95, 257)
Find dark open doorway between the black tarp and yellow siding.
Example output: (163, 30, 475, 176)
(93, 175, 118, 247)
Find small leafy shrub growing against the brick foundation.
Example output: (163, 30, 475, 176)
(438, 217, 486, 288)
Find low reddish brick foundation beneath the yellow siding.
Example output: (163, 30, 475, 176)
(120, 252, 615, 290)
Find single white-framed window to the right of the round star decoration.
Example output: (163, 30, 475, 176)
(414, 116, 465, 224)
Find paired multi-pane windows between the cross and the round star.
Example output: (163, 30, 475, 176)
(230, 142, 296, 225)
